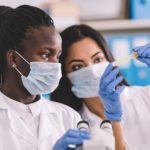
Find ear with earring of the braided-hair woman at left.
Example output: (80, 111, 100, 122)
(6, 50, 17, 68)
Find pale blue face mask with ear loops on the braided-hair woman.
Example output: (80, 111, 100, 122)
(15, 52, 62, 95)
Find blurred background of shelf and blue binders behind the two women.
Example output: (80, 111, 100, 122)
(0, 0, 150, 85)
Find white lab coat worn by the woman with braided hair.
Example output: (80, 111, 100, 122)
(0, 92, 81, 150)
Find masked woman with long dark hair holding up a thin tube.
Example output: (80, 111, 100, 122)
(51, 25, 150, 150)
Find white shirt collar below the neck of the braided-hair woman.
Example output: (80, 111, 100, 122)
(1, 92, 42, 118)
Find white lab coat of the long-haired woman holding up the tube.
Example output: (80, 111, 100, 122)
(80, 86, 150, 150)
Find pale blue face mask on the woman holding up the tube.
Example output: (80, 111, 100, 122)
(67, 62, 109, 98)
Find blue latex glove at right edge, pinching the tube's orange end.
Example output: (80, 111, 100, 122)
(133, 44, 150, 67)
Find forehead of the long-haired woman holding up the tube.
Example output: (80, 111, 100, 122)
(67, 37, 102, 59)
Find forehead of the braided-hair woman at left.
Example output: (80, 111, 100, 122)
(22, 27, 61, 51)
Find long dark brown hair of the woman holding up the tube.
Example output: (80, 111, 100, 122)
(51, 24, 128, 111)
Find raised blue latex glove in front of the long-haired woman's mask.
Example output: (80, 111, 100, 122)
(99, 64, 124, 121)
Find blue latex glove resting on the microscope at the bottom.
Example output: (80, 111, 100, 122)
(53, 129, 90, 150)
